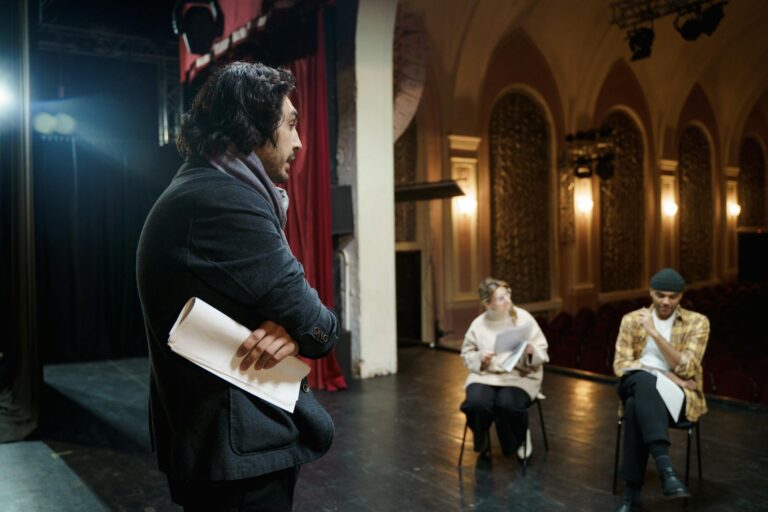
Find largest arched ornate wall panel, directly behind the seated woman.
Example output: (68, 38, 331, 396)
(489, 93, 552, 303)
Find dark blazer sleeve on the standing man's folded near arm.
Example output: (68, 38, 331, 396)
(187, 182, 338, 358)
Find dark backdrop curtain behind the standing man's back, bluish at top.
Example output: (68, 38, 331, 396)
(34, 136, 178, 363)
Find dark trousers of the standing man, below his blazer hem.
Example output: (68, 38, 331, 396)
(168, 467, 299, 512)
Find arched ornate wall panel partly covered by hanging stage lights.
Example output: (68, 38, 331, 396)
(600, 111, 645, 292)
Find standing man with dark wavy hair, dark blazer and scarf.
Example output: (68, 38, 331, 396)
(137, 62, 338, 511)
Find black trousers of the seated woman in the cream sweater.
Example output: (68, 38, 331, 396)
(461, 383, 531, 455)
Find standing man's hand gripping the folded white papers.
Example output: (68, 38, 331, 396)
(236, 320, 299, 372)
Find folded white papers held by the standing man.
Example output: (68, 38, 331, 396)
(168, 297, 310, 412)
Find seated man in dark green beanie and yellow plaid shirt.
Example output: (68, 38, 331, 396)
(613, 268, 709, 512)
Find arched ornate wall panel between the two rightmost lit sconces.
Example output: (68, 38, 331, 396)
(679, 126, 714, 283)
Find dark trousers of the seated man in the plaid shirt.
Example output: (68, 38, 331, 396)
(619, 371, 685, 484)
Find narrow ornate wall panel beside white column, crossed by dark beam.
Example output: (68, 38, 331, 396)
(395, 121, 419, 242)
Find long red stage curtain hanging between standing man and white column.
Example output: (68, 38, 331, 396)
(286, 9, 347, 391)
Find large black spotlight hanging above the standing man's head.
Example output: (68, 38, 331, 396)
(173, 0, 224, 55)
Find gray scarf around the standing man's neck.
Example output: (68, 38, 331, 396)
(208, 148, 289, 246)
